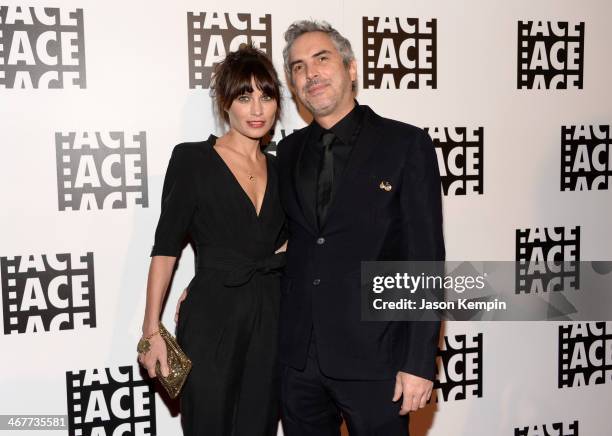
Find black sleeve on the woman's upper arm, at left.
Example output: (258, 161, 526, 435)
(151, 144, 197, 257)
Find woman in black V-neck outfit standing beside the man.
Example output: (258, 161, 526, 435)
(139, 47, 286, 436)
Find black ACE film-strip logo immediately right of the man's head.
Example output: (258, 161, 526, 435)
(362, 17, 437, 89)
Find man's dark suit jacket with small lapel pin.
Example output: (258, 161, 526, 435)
(277, 106, 445, 380)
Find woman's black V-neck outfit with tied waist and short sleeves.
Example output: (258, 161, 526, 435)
(151, 135, 285, 436)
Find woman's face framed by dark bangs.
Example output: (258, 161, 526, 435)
(227, 78, 277, 139)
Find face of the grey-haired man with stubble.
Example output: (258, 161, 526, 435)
(289, 32, 357, 117)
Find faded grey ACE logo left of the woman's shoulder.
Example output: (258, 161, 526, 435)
(55, 131, 149, 211)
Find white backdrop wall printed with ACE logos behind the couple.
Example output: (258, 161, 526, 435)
(0, 0, 612, 436)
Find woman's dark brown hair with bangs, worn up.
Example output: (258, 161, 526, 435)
(210, 44, 281, 122)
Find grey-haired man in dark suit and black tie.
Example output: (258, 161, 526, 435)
(277, 21, 444, 436)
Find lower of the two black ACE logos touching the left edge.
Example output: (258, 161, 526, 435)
(0, 252, 96, 334)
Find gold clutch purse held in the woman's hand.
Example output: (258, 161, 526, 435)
(138, 322, 191, 398)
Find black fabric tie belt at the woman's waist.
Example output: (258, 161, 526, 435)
(197, 247, 286, 287)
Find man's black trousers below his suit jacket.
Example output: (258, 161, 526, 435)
(281, 335, 408, 436)
